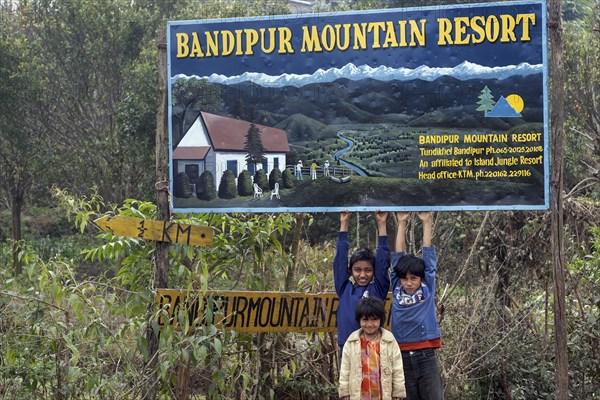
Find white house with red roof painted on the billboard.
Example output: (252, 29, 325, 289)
(172, 111, 290, 187)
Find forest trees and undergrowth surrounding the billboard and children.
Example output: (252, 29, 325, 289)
(0, 0, 600, 400)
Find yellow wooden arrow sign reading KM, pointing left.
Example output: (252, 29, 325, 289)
(94, 215, 213, 246)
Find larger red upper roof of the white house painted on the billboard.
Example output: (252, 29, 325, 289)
(200, 111, 290, 153)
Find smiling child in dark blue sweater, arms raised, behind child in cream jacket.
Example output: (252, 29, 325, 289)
(333, 211, 390, 354)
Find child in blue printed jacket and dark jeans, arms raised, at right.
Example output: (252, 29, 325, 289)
(391, 212, 444, 400)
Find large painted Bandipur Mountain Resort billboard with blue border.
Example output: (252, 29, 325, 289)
(167, 1, 549, 212)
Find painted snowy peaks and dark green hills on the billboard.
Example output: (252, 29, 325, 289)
(171, 62, 544, 209)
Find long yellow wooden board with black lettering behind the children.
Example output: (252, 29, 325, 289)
(156, 289, 391, 333)
